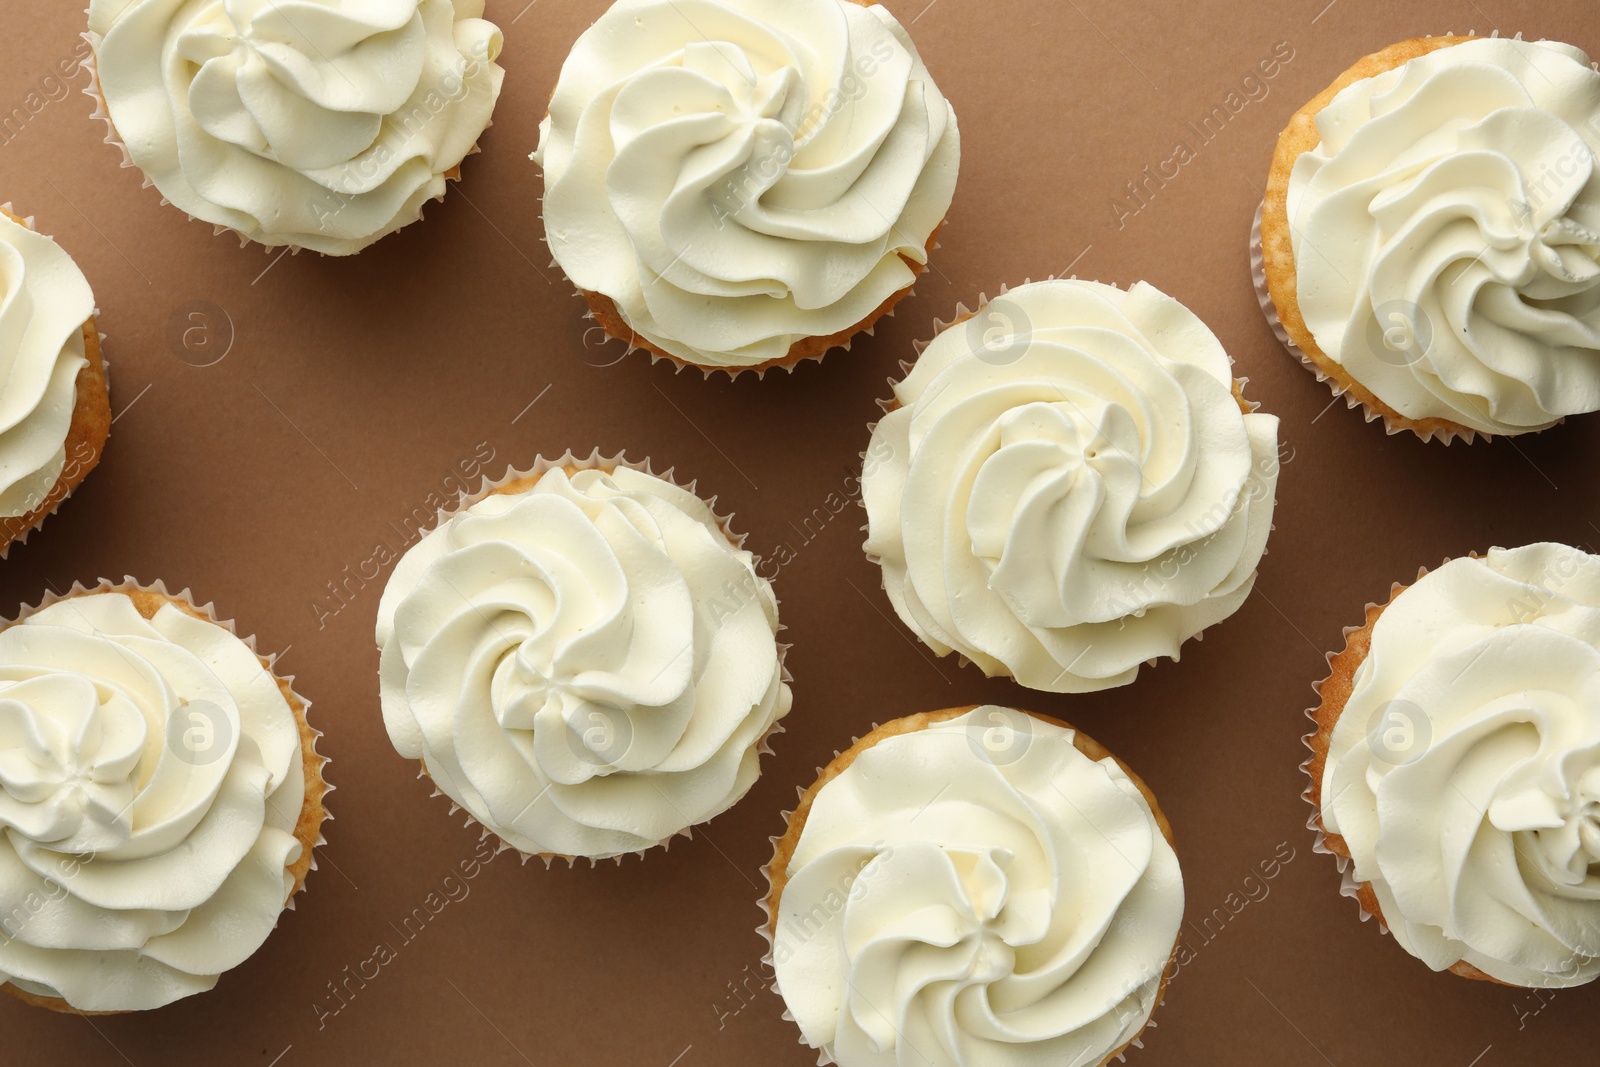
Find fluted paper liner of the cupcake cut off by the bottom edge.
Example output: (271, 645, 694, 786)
(755, 704, 1184, 1067)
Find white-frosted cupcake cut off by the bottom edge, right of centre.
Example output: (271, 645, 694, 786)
(762, 707, 1184, 1067)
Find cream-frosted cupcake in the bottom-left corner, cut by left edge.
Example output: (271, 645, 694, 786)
(0, 579, 330, 1014)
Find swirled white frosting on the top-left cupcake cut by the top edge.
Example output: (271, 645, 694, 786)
(90, 0, 504, 256)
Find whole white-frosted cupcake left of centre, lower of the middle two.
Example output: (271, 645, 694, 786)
(378, 453, 790, 861)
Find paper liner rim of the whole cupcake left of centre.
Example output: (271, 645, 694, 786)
(406, 448, 794, 870)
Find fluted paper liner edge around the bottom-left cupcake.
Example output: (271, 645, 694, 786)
(0, 576, 334, 1016)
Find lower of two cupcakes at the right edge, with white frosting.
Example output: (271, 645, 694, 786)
(1306, 544, 1600, 989)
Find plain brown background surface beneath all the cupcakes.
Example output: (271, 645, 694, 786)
(0, 0, 1600, 1067)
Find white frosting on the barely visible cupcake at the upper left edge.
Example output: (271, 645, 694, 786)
(0, 211, 94, 518)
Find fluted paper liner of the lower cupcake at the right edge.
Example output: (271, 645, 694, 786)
(1301, 553, 1509, 985)
